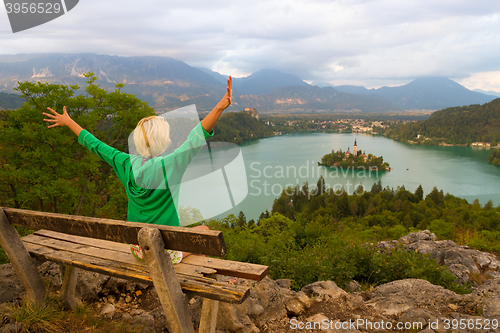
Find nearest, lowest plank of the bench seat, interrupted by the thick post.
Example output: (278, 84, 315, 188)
(24, 242, 250, 303)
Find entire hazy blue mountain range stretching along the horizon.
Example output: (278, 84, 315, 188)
(0, 53, 496, 113)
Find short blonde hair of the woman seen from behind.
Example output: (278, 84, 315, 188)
(134, 116, 172, 157)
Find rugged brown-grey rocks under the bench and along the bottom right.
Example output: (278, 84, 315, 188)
(0, 231, 500, 333)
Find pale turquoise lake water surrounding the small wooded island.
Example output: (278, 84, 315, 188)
(197, 133, 500, 221)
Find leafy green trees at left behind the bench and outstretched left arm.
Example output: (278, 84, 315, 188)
(0, 73, 154, 219)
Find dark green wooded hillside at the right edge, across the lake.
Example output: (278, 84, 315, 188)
(386, 98, 500, 145)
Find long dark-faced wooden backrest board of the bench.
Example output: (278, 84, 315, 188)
(0, 208, 226, 257)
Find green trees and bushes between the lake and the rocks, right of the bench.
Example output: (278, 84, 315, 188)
(212, 179, 500, 293)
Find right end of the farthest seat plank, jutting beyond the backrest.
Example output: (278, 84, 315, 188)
(182, 256, 269, 281)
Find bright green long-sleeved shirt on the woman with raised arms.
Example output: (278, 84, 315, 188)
(78, 123, 213, 226)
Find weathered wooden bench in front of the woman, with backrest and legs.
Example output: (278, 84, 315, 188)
(0, 208, 269, 333)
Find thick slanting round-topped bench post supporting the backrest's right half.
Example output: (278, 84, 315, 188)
(138, 228, 194, 333)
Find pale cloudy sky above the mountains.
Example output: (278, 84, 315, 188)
(0, 0, 500, 92)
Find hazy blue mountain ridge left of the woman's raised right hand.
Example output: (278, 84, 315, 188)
(0, 53, 225, 110)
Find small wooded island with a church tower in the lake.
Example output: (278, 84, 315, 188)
(318, 140, 392, 171)
